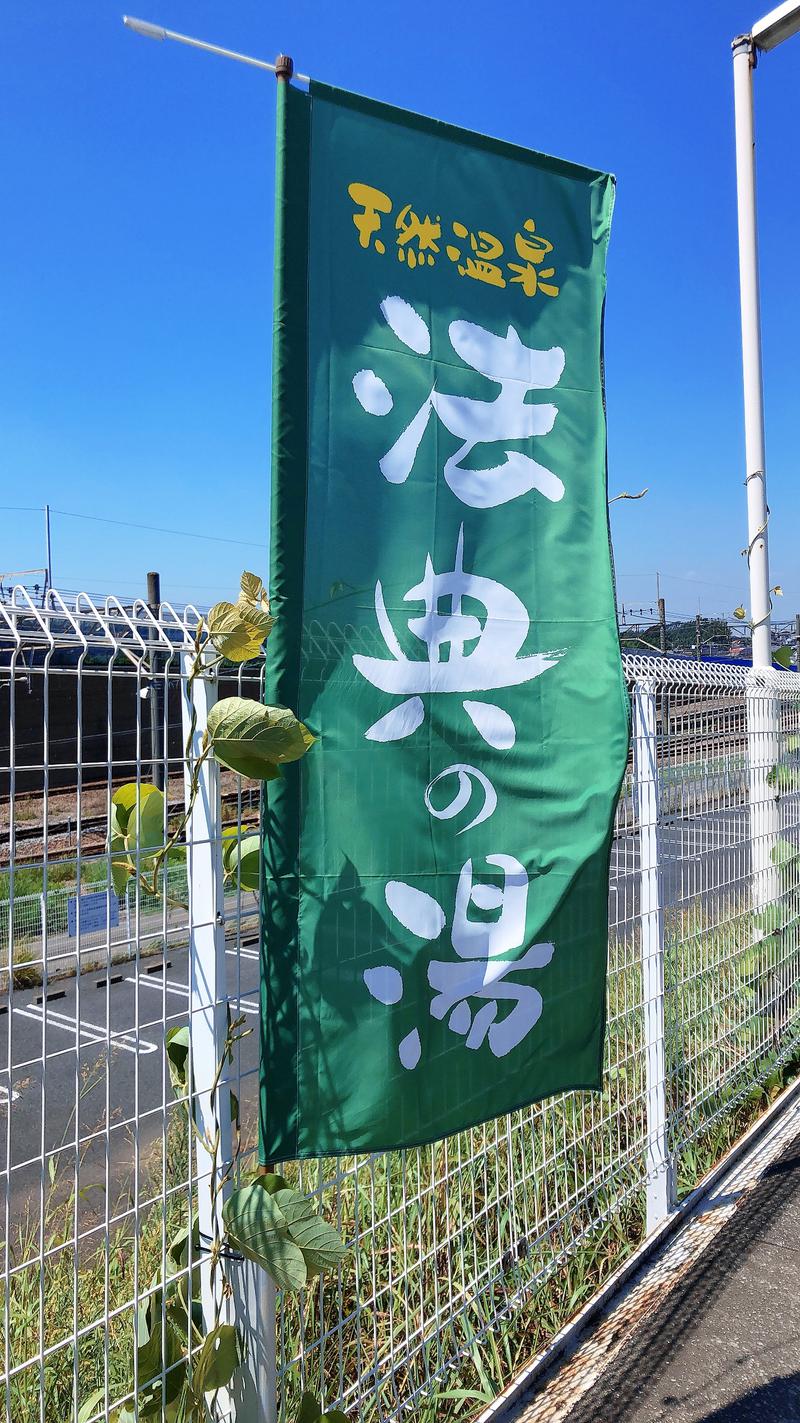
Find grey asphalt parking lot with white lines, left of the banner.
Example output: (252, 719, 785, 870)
(0, 943, 259, 1214)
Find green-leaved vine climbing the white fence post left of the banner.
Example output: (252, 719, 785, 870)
(78, 572, 346, 1423)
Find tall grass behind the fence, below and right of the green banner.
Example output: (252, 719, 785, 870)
(271, 901, 800, 1423)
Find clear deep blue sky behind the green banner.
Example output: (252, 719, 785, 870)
(0, 0, 800, 616)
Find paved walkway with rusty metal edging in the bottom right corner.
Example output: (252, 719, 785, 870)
(500, 1103, 800, 1423)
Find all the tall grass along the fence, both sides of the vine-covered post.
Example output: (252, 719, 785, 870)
(0, 901, 800, 1423)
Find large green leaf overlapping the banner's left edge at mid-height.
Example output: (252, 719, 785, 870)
(208, 697, 315, 781)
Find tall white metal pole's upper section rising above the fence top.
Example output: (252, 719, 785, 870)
(733, 36, 772, 667)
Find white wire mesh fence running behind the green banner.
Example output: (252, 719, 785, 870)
(0, 593, 800, 1423)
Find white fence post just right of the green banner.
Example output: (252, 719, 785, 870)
(633, 680, 675, 1235)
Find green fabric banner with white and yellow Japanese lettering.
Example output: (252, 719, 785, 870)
(260, 83, 628, 1161)
